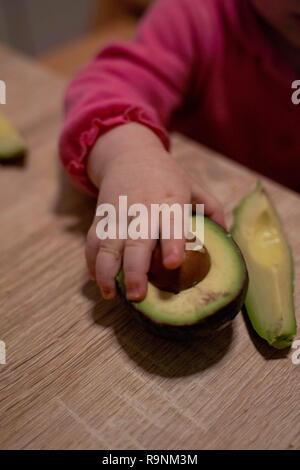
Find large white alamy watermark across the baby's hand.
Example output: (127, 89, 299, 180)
(96, 196, 204, 250)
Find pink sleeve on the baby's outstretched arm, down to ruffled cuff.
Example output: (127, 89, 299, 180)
(59, 0, 206, 194)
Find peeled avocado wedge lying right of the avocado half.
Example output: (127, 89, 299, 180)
(231, 182, 297, 349)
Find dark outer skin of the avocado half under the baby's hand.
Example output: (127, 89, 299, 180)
(117, 228, 249, 341)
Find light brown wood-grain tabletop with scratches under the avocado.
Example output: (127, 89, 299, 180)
(0, 47, 300, 449)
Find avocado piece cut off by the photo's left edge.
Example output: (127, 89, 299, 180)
(0, 114, 26, 163)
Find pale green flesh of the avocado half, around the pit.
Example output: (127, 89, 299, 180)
(119, 215, 247, 326)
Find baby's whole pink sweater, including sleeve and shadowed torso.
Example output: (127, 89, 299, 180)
(60, 0, 300, 194)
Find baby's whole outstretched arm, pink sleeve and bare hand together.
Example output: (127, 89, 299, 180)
(60, 0, 223, 300)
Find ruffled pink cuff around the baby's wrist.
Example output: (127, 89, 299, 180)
(59, 106, 170, 196)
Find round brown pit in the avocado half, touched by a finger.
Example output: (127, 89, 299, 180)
(148, 244, 211, 294)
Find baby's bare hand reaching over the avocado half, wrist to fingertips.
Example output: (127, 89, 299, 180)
(86, 123, 224, 301)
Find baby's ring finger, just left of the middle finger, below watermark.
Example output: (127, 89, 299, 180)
(95, 239, 124, 300)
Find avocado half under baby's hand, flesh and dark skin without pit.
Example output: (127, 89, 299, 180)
(117, 214, 248, 340)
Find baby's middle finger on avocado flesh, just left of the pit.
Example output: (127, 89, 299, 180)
(123, 239, 156, 301)
